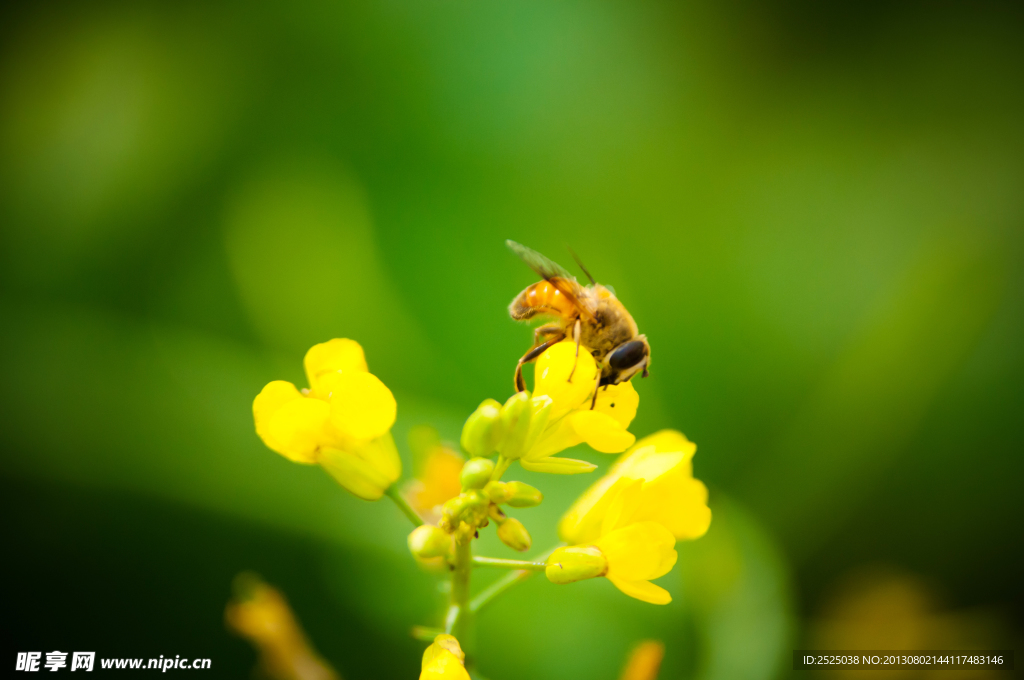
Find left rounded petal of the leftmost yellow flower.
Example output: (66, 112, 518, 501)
(253, 380, 333, 463)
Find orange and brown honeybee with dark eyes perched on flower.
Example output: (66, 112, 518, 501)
(505, 240, 650, 399)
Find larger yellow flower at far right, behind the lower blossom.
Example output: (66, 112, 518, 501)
(558, 430, 711, 544)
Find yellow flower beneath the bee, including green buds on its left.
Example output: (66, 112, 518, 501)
(462, 340, 640, 474)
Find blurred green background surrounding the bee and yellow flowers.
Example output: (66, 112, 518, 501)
(0, 0, 1024, 680)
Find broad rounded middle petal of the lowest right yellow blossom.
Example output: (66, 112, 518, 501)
(594, 521, 678, 581)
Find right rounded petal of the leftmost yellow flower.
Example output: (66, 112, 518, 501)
(331, 373, 397, 439)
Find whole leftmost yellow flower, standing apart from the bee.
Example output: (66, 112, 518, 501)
(253, 338, 401, 501)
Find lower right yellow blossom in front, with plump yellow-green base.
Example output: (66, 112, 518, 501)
(545, 481, 678, 604)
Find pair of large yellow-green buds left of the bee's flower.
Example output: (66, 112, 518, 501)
(461, 391, 554, 461)
